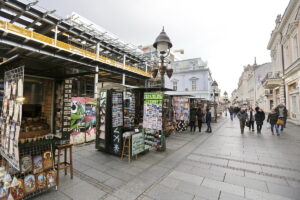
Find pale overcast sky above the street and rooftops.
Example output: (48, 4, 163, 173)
(39, 0, 289, 92)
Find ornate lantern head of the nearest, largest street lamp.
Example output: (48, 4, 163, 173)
(152, 27, 173, 88)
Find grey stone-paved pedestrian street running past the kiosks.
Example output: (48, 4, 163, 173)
(36, 119, 300, 200)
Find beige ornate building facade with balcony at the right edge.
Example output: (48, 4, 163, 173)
(264, 0, 300, 125)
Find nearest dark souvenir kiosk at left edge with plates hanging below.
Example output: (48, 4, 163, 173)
(0, 60, 96, 199)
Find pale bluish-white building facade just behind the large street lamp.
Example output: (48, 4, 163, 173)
(165, 58, 213, 101)
